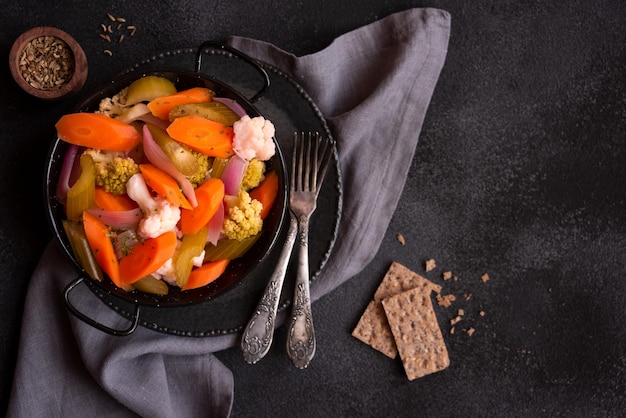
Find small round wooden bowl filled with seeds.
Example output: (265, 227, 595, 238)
(9, 26, 88, 100)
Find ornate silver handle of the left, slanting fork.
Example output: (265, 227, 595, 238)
(241, 214, 298, 364)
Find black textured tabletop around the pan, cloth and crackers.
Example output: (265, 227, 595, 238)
(0, 0, 626, 417)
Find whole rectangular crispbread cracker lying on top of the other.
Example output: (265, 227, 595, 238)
(382, 288, 450, 380)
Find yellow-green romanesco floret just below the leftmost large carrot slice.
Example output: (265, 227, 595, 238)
(85, 149, 139, 194)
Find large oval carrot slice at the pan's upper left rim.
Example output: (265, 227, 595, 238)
(55, 112, 141, 151)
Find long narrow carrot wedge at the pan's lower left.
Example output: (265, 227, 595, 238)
(83, 211, 127, 288)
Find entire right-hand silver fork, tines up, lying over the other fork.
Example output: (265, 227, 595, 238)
(287, 132, 334, 369)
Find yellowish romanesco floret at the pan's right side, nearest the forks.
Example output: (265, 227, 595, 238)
(222, 190, 263, 241)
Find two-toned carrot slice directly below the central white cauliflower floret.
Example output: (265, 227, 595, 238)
(119, 231, 177, 284)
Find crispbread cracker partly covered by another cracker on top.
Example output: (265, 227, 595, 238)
(352, 261, 441, 358)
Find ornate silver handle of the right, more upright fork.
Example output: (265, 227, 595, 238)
(287, 215, 315, 369)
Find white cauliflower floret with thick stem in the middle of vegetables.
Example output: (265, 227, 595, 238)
(126, 173, 180, 239)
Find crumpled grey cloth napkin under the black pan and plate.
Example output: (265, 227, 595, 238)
(8, 9, 450, 417)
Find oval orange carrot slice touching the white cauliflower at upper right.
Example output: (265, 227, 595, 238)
(167, 115, 234, 158)
